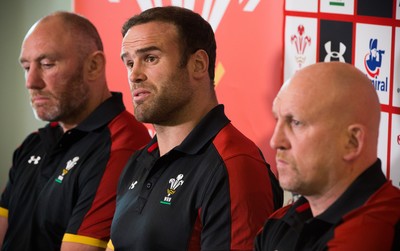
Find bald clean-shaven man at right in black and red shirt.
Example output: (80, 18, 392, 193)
(255, 62, 400, 251)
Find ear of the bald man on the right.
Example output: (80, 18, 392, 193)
(343, 124, 365, 161)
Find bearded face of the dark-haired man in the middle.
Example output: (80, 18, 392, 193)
(121, 22, 194, 125)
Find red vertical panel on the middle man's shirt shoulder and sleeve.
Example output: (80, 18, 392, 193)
(213, 124, 274, 250)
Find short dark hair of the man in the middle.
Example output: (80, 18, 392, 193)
(121, 6, 217, 84)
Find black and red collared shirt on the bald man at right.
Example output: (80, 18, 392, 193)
(256, 160, 400, 251)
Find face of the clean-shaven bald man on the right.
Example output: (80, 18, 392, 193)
(270, 78, 343, 195)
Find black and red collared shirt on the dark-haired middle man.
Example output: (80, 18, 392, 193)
(111, 105, 282, 250)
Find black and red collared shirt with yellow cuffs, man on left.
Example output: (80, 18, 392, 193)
(0, 93, 150, 251)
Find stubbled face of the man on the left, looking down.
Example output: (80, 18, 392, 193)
(20, 21, 88, 122)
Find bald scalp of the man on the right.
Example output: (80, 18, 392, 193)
(277, 62, 380, 165)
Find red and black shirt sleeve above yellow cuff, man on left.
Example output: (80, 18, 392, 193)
(66, 111, 150, 245)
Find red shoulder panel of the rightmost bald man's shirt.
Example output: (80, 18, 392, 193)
(329, 182, 400, 250)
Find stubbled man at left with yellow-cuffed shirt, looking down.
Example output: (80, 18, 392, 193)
(0, 12, 150, 251)
